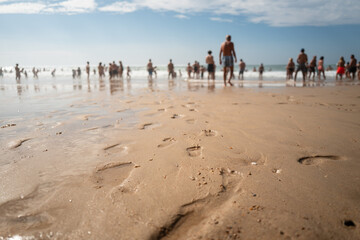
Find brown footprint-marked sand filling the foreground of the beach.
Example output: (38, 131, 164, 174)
(0, 86, 360, 239)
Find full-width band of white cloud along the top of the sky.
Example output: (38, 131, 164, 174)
(0, 0, 360, 26)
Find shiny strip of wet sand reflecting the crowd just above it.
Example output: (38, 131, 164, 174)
(0, 76, 360, 100)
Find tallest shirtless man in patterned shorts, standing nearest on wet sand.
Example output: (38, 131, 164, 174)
(219, 35, 237, 86)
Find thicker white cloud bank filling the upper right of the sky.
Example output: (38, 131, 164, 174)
(100, 0, 360, 26)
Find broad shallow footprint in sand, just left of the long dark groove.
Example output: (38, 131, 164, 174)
(92, 162, 134, 189)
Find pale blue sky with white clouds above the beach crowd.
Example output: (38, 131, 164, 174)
(0, 0, 360, 66)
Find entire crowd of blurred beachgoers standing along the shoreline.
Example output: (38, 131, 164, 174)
(0, 35, 360, 86)
